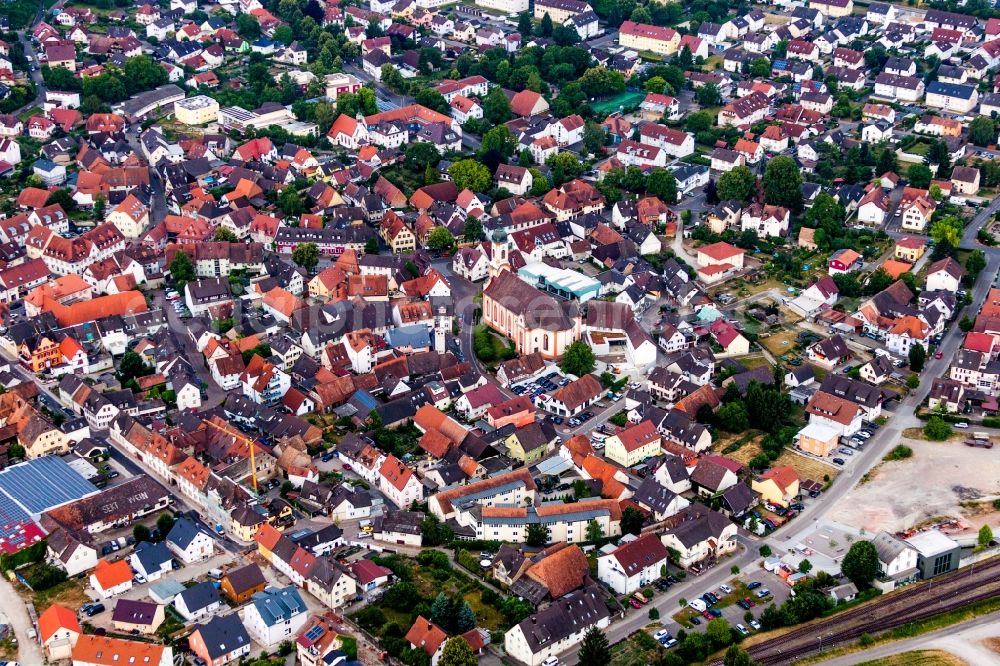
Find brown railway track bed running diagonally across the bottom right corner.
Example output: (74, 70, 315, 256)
(728, 557, 1000, 666)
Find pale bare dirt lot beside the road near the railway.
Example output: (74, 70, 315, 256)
(830, 437, 1000, 532)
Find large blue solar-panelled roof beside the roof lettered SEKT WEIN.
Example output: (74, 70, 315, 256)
(0, 456, 97, 520)
